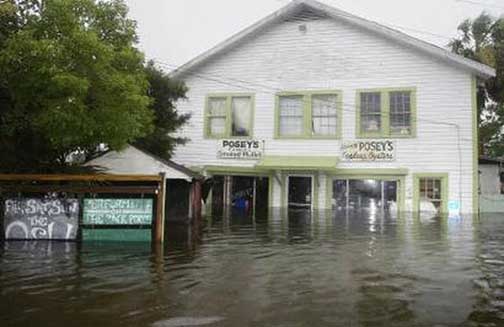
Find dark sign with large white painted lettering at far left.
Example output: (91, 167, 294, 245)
(4, 198, 79, 240)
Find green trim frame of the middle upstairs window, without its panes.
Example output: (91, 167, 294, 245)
(274, 90, 343, 140)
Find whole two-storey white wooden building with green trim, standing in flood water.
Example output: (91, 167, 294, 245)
(172, 0, 495, 213)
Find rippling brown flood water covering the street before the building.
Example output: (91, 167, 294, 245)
(0, 212, 504, 327)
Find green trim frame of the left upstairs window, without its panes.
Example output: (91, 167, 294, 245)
(203, 93, 255, 139)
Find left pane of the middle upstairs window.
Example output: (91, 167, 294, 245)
(279, 95, 304, 135)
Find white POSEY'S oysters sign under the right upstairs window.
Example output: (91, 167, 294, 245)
(341, 140, 396, 161)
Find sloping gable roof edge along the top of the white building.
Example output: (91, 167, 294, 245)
(170, 0, 496, 79)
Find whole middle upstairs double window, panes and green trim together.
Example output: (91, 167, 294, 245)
(275, 91, 341, 138)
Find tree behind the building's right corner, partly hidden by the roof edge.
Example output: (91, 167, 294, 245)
(449, 12, 504, 157)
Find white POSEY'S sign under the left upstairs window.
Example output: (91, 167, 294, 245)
(217, 140, 264, 160)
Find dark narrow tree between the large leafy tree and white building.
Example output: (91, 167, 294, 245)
(135, 62, 190, 159)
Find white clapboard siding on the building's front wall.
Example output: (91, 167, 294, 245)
(174, 19, 473, 212)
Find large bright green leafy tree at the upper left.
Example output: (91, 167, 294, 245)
(0, 0, 154, 172)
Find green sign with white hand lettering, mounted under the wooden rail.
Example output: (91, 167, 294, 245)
(83, 199, 153, 225)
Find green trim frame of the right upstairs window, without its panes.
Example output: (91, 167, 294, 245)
(355, 87, 417, 138)
